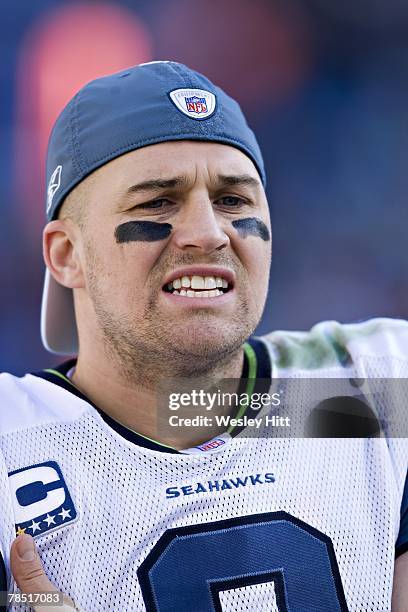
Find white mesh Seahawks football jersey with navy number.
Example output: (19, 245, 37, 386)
(0, 319, 408, 612)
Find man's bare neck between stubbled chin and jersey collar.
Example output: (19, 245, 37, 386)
(72, 347, 244, 450)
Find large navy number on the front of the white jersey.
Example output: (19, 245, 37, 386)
(138, 512, 348, 612)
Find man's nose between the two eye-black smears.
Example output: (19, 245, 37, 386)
(173, 198, 230, 254)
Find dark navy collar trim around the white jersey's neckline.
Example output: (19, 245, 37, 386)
(32, 338, 272, 455)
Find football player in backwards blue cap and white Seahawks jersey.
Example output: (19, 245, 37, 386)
(0, 62, 408, 612)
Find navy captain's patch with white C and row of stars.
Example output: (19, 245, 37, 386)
(9, 461, 77, 537)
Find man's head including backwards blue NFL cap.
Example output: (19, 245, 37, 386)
(43, 62, 270, 368)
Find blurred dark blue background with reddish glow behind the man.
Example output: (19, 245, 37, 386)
(0, 0, 408, 373)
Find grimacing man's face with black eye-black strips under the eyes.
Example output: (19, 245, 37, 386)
(79, 141, 271, 368)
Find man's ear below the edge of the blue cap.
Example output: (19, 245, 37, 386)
(43, 219, 85, 289)
